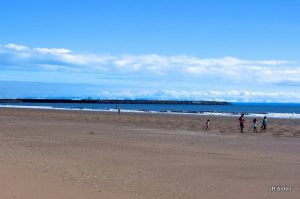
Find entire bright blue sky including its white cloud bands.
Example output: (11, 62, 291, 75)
(0, 0, 300, 103)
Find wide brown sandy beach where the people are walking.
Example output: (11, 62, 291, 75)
(0, 108, 300, 199)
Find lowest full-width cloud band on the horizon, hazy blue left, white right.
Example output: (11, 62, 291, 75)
(0, 81, 300, 102)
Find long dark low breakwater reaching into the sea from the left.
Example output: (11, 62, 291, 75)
(0, 98, 231, 105)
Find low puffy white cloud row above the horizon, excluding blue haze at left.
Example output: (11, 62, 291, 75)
(97, 90, 300, 102)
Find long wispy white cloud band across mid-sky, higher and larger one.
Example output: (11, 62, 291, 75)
(0, 43, 300, 83)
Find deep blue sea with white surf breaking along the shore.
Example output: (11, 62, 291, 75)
(0, 102, 300, 119)
